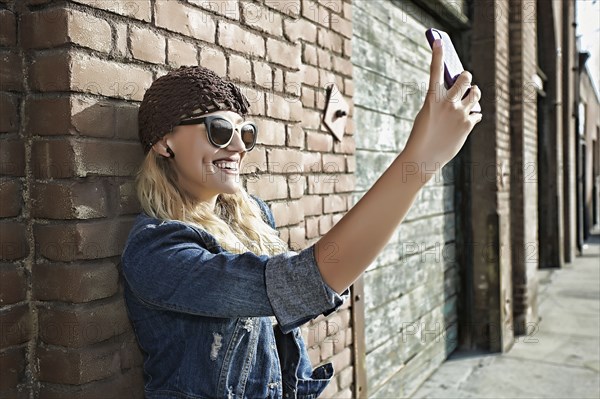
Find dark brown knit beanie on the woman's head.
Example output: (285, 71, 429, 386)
(138, 66, 250, 154)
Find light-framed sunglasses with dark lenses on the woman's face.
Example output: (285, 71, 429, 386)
(178, 115, 258, 151)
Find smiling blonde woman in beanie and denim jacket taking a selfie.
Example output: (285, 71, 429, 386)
(122, 41, 481, 398)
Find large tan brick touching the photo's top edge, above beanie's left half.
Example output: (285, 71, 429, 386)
(154, 0, 217, 43)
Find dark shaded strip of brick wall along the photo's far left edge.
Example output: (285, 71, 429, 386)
(0, 0, 34, 398)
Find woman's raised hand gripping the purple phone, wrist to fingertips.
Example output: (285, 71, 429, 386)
(404, 39, 482, 180)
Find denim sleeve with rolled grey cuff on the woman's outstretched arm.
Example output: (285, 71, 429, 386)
(121, 221, 347, 333)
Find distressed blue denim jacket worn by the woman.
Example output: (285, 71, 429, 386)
(121, 195, 350, 399)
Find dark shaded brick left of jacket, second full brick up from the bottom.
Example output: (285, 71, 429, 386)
(38, 295, 131, 348)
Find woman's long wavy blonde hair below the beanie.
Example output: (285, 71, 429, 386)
(135, 150, 289, 255)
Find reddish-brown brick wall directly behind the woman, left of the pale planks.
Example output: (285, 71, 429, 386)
(0, 0, 355, 398)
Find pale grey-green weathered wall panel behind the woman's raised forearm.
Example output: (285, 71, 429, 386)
(353, 0, 459, 398)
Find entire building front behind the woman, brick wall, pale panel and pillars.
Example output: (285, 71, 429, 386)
(0, 0, 600, 398)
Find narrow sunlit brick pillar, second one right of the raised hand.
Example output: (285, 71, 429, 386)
(509, 0, 539, 335)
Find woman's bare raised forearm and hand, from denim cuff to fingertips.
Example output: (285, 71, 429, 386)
(315, 41, 482, 292)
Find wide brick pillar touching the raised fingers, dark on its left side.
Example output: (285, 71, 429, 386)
(465, 0, 513, 352)
